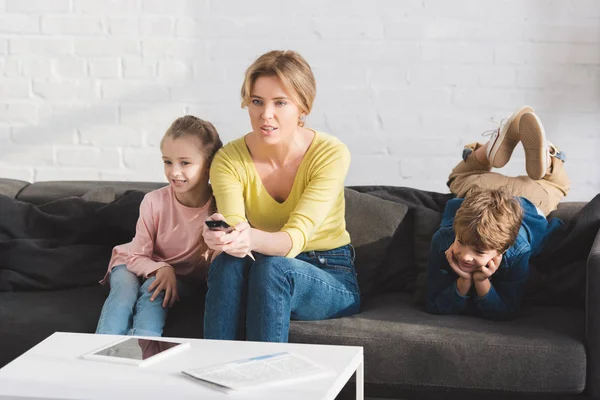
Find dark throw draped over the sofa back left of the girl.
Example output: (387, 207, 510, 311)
(0, 191, 144, 291)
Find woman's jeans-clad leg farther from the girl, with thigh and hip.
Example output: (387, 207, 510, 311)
(246, 245, 360, 342)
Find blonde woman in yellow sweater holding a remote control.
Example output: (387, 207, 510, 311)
(203, 51, 360, 342)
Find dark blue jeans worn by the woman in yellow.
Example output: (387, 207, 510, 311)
(204, 245, 360, 342)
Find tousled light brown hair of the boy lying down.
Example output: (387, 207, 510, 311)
(454, 189, 523, 253)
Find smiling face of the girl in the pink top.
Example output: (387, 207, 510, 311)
(161, 136, 209, 200)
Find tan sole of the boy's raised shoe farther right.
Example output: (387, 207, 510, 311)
(519, 113, 548, 181)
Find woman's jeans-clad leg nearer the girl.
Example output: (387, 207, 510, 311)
(204, 253, 252, 340)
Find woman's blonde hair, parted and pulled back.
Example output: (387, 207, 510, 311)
(241, 50, 317, 126)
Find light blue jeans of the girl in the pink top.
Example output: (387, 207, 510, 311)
(96, 264, 198, 336)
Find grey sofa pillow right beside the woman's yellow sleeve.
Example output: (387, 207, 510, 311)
(345, 188, 408, 298)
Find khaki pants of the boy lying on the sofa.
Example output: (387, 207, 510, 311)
(448, 143, 571, 216)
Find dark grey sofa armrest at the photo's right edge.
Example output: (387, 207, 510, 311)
(585, 232, 600, 399)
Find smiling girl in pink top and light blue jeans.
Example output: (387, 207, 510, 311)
(96, 115, 222, 336)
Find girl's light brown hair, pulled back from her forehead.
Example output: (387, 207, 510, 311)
(160, 115, 223, 165)
